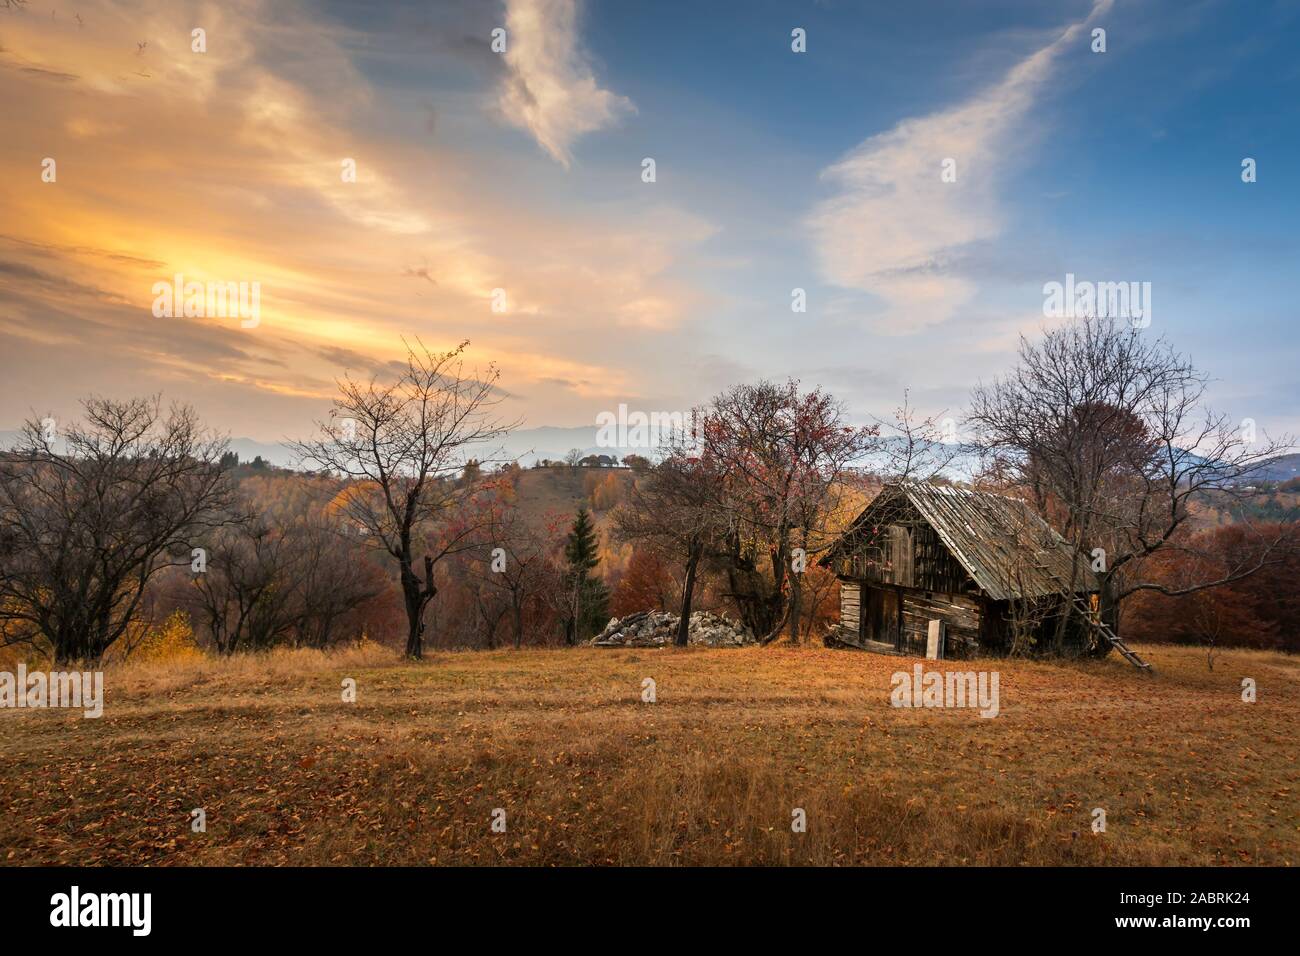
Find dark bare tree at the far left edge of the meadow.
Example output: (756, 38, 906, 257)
(0, 398, 233, 663)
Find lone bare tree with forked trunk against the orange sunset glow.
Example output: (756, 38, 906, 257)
(293, 342, 514, 658)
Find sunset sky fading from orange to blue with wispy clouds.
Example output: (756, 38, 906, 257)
(0, 0, 1300, 442)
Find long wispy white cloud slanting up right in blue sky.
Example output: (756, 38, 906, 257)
(807, 0, 1113, 332)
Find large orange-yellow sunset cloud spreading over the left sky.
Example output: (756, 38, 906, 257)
(0, 0, 718, 441)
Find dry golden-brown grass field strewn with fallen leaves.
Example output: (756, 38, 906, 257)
(0, 646, 1300, 865)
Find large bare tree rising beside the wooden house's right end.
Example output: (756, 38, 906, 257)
(970, 317, 1292, 653)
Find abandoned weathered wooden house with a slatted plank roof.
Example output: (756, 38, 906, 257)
(820, 481, 1145, 666)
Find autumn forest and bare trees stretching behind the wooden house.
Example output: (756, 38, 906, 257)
(0, 319, 1300, 663)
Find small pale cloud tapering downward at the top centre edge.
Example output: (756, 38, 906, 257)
(499, 0, 634, 169)
